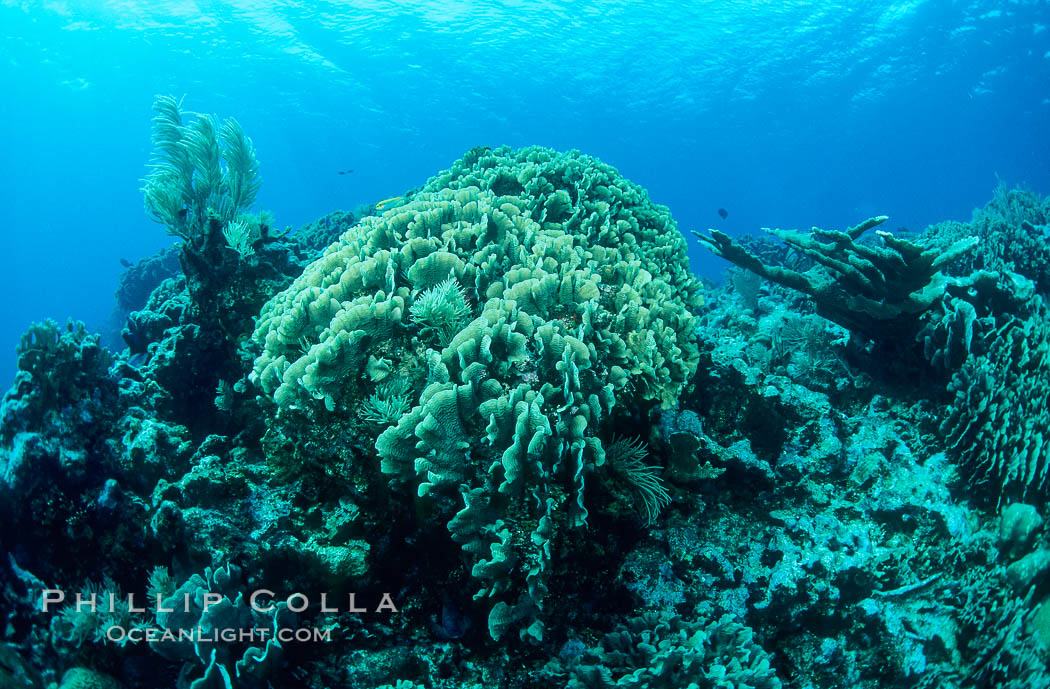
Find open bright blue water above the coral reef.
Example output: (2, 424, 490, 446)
(0, 0, 1050, 384)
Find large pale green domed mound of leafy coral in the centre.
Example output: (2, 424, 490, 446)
(251, 147, 700, 638)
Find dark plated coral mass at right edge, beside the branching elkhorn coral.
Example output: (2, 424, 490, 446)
(919, 191, 1050, 504)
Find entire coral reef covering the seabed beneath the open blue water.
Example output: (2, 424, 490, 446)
(0, 115, 1050, 689)
